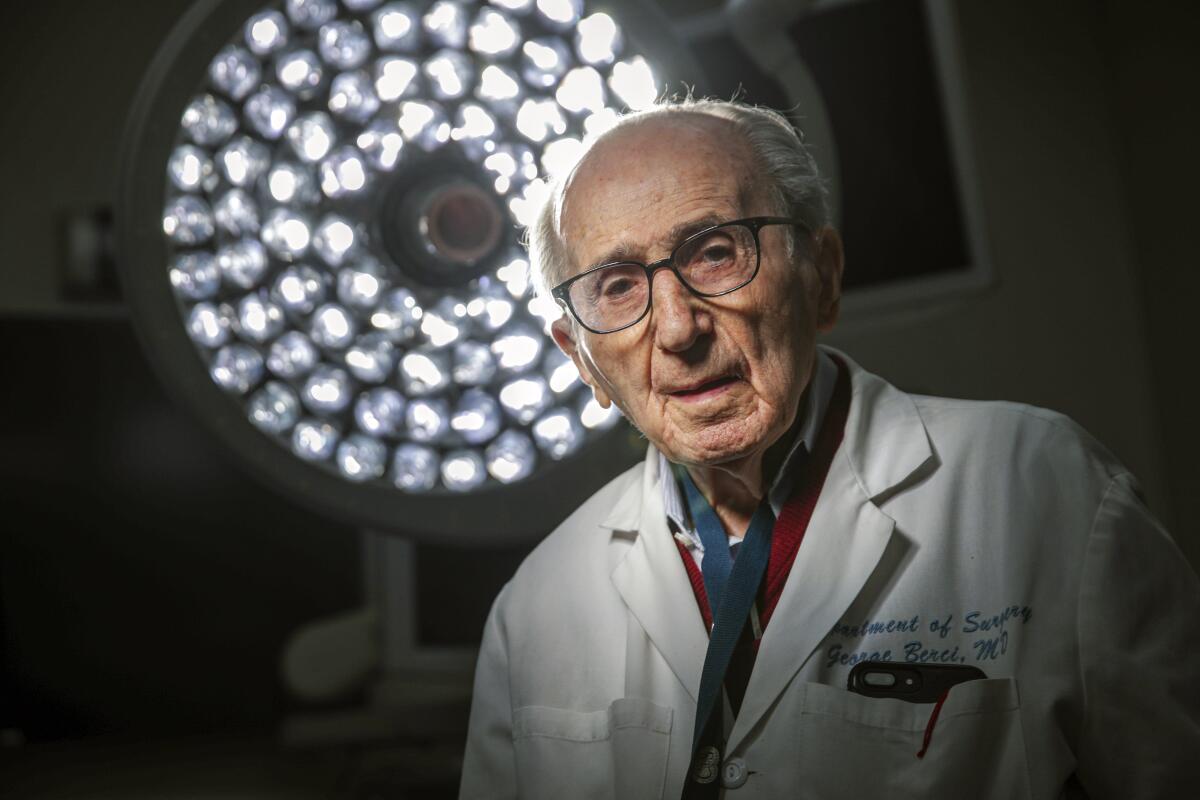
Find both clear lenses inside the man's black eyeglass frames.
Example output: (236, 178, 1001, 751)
(569, 224, 758, 331)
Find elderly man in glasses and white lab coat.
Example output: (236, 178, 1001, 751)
(462, 101, 1200, 799)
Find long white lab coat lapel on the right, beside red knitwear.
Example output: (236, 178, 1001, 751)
(727, 353, 935, 752)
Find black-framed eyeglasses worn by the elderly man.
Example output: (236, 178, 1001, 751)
(551, 217, 808, 333)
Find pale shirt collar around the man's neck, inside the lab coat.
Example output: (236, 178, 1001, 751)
(659, 348, 838, 552)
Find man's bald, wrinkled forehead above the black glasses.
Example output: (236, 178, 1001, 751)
(559, 113, 762, 277)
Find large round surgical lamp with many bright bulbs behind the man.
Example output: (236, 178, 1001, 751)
(116, 0, 700, 545)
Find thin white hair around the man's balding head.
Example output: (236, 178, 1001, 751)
(527, 97, 829, 294)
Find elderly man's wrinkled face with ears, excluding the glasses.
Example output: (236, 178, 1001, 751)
(553, 115, 841, 465)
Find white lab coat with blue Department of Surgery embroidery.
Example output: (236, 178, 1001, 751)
(462, 354, 1200, 800)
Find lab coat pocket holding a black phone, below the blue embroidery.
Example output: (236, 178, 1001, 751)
(798, 678, 1031, 800)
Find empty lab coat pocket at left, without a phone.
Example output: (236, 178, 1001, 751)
(512, 697, 673, 800)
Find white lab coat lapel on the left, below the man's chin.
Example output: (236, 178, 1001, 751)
(604, 449, 708, 699)
